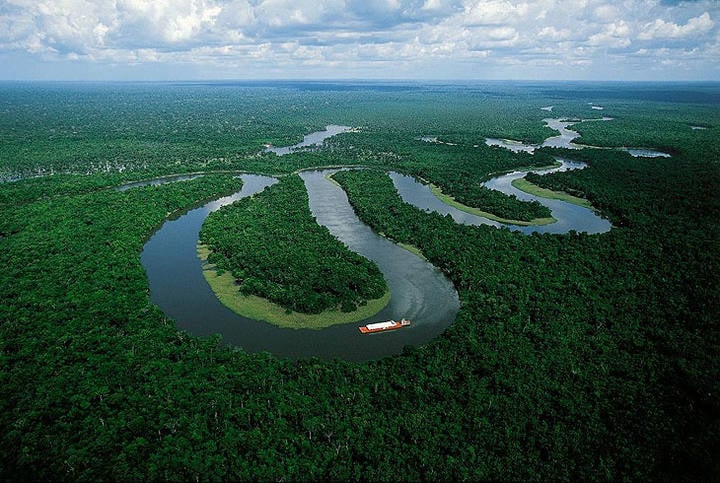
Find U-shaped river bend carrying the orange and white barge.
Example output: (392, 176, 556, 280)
(141, 172, 459, 361)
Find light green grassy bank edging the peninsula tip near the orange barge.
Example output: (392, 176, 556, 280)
(197, 244, 390, 329)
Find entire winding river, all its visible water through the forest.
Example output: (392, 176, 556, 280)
(139, 116, 624, 361)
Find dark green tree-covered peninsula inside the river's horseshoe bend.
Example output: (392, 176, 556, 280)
(200, 175, 387, 314)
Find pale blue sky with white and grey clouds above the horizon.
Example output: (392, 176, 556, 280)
(0, 0, 720, 81)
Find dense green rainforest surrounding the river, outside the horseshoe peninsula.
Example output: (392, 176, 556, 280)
(0, 83, 720, 481)
